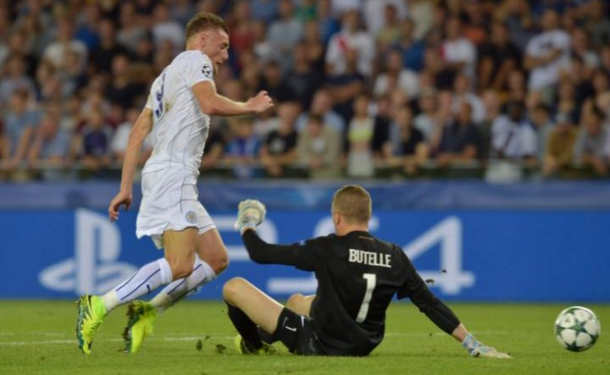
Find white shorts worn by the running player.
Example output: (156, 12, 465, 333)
(136, 168, 216, 249)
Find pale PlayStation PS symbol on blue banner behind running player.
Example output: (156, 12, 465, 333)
(39, 209, 136, 294)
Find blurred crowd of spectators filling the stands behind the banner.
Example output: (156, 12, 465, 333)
(0, 0, 610, 179)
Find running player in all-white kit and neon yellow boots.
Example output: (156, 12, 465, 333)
(76, 12, 273, 354)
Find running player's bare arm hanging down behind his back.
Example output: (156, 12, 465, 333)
(108, 108, 152, 221)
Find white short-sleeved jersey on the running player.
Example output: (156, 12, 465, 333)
(142, 51, 214, 175)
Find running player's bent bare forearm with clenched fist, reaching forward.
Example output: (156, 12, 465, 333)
(193, 81, 273, 116)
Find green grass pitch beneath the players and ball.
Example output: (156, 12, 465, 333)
(0, 301, 610, 375)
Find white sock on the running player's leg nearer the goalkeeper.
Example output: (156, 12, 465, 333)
(150, 255, 216, 313)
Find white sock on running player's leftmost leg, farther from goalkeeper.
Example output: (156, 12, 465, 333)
(102, 258, 172, 312)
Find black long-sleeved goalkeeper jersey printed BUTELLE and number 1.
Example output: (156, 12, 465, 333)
(243, 230, 459, 355)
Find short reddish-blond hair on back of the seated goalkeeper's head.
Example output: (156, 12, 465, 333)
(332, 185, 373, 225)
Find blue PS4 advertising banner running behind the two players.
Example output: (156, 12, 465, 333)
(0, 209, 610, 302)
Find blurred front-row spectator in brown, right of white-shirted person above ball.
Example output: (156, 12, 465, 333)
(539, 113, 578, 176)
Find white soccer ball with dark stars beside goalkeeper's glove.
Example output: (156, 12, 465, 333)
(555, 306, 601, 352)
